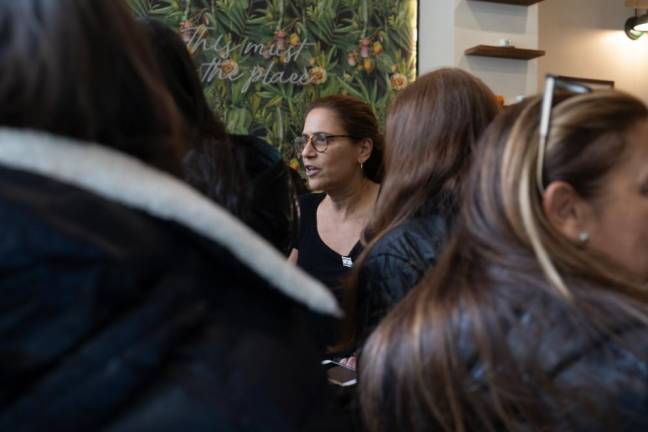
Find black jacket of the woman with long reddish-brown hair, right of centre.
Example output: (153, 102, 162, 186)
(356, 214, 449, 347)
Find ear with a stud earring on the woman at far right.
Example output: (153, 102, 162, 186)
(542, 181, 592, 242)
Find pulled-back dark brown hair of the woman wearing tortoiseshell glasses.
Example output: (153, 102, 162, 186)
(306, 96, 383, 183)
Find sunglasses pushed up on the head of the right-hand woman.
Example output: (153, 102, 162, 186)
(536, 75, 592, 195)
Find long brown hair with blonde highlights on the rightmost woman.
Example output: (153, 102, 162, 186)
(360, 92, 648, 432)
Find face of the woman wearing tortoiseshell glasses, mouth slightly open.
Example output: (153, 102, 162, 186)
(301, 108, 362, 192)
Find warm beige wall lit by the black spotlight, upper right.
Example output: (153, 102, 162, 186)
(540, 0, 648, 103)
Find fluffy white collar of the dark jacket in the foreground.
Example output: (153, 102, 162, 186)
(0, 128, 341, 316)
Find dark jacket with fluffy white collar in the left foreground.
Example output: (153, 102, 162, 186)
(0, 130, 346, 432)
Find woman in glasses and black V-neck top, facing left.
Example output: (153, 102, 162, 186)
(290, 96, 382, 352)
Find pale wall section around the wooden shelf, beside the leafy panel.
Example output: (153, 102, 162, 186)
(418, 0, 538, 102)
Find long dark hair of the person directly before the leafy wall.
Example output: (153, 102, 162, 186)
(140, 18, 247, 217)
